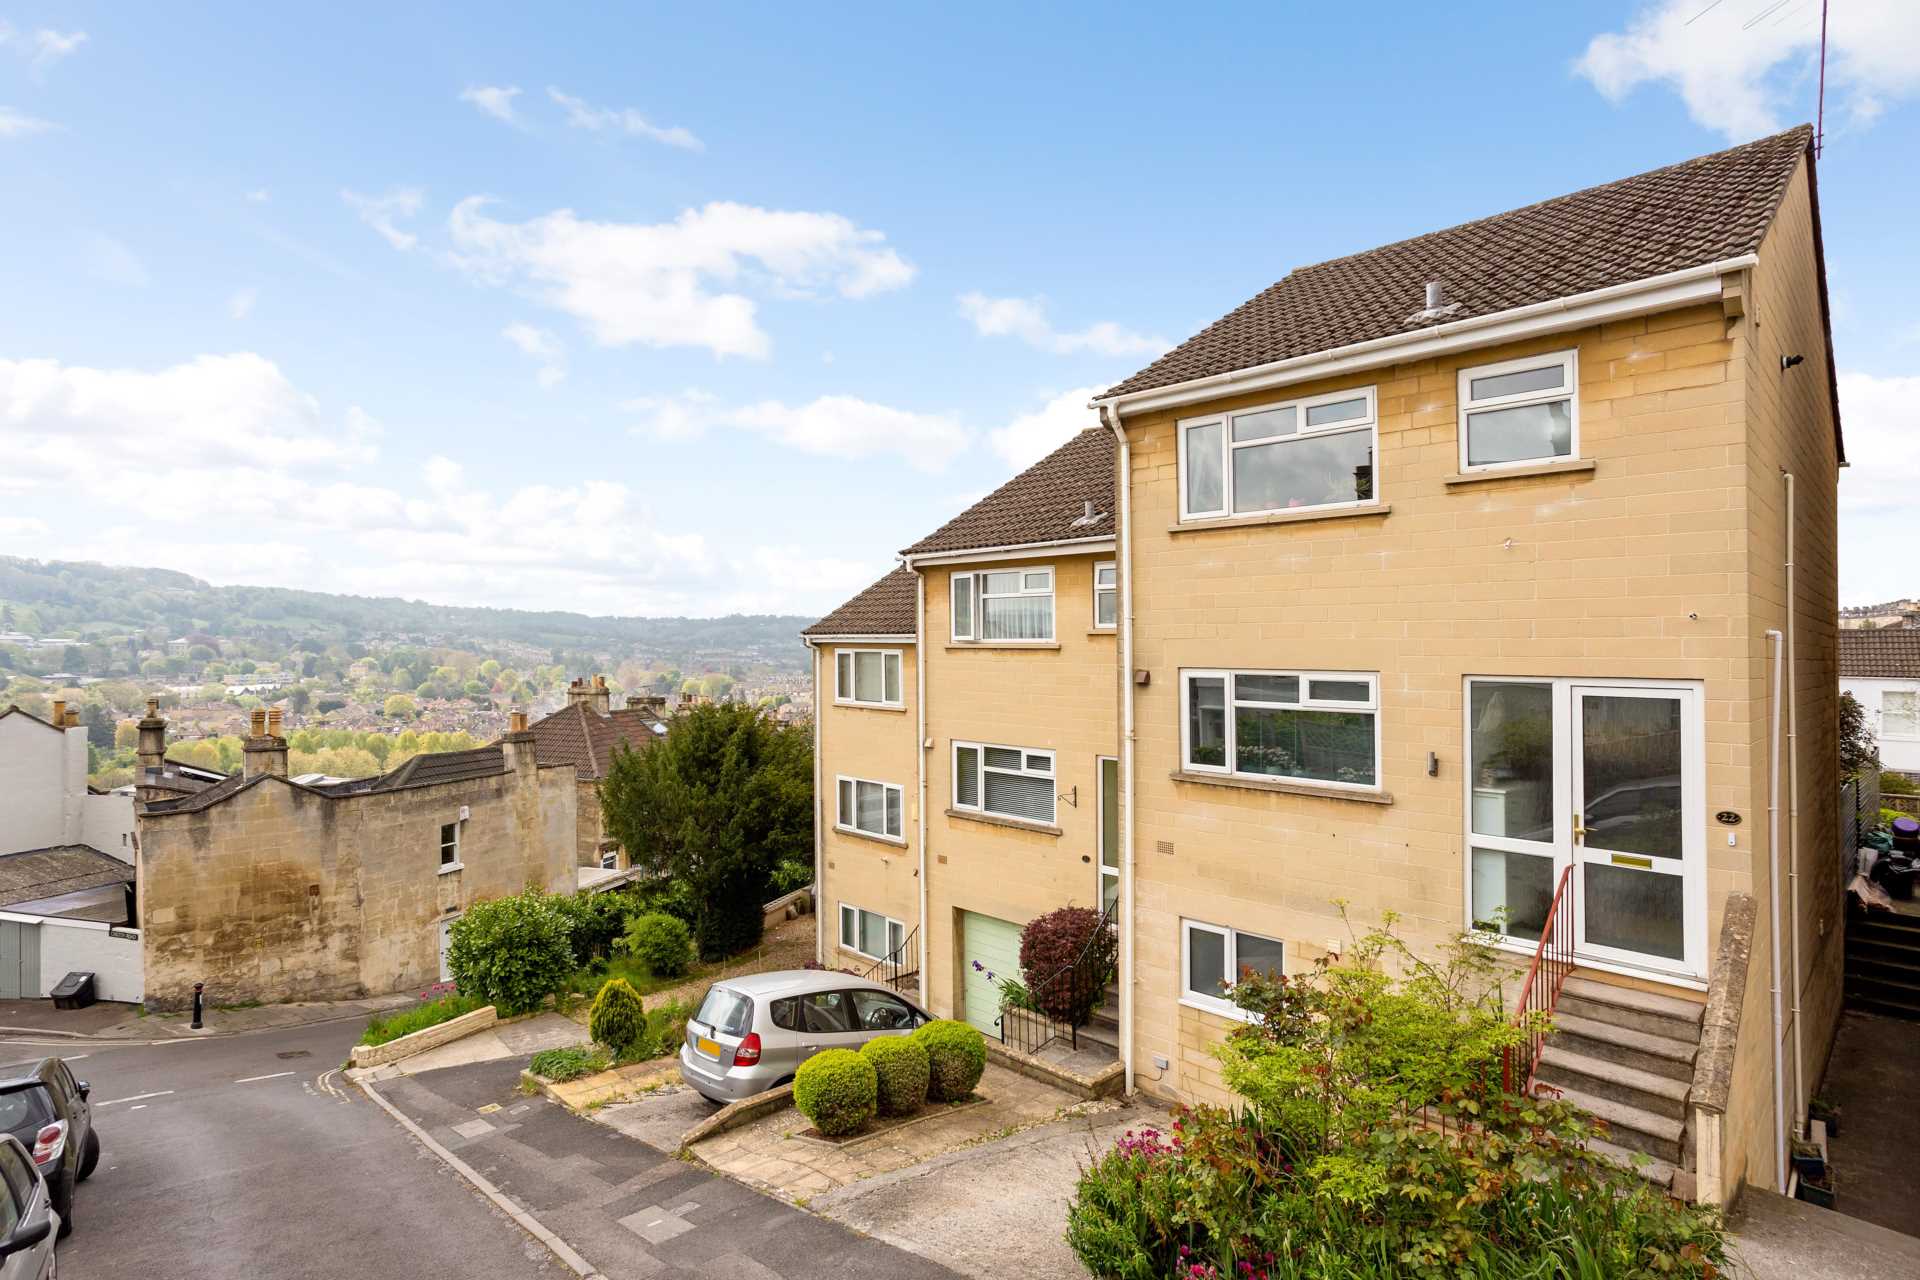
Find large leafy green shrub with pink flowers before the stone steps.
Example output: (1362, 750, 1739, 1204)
(1068, 919, 1726, 1280)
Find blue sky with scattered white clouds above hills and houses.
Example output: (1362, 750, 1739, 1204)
(0, 0, 1920, 614)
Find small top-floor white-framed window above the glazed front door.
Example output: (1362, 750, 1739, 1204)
(1459, 351, 1580, 472)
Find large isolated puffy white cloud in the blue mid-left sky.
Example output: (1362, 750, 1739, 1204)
(447, 196, 914, 357)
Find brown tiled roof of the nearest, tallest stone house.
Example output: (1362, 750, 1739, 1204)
(1102, 125, 1812, 399)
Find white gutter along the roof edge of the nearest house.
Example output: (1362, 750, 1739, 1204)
(1092, 253, 1761, 415)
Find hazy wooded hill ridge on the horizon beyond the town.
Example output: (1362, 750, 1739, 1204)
(0, 557, 812, 670)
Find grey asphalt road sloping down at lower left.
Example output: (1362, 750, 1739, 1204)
(11, 1019, 572, 1280)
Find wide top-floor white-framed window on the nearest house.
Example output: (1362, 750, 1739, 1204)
(1179, 386, 1380, 520)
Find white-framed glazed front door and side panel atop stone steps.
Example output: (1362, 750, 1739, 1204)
(1467, 679, 1707, 977)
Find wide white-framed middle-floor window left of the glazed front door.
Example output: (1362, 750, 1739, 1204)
(1181, 670, 1380, 789)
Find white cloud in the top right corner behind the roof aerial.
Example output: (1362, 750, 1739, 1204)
(1574, 0, 1920, 142)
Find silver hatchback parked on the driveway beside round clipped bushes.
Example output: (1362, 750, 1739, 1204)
(680, 969, 933, 1102)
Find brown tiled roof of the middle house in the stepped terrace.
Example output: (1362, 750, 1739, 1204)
(902, 426, 1116, 556)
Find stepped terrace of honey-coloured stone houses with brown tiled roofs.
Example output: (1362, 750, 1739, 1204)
(806, 129, 1843, 1201)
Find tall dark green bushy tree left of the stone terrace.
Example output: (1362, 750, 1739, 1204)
(601, 704, 812, 960)
